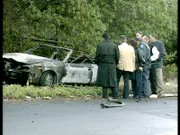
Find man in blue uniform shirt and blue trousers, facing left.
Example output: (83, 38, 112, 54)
(136, 31, 151, 97)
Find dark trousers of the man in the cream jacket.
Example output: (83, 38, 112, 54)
(116, 68, 129, 98)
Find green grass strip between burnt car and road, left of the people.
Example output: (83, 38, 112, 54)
(3, 85, 101, 99)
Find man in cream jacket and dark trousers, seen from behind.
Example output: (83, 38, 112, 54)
(117, 35, 135, 98)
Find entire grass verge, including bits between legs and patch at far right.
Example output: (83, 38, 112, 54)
(3, 78, 178, 100)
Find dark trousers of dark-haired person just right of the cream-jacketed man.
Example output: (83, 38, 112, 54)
(132, 70, 143, 97)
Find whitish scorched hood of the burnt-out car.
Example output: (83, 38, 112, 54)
(3, 53, 51, 64)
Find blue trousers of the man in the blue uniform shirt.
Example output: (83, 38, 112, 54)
(141, 65, 150, 97)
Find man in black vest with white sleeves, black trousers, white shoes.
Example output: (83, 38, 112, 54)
(142, 36, 159, 97)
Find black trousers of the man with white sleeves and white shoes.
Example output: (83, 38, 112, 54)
(149, 64, 157, 94)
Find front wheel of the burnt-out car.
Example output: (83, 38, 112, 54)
(40, 71, 54, 86)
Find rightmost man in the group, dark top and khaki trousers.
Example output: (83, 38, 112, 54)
(150, 34, 166, 97)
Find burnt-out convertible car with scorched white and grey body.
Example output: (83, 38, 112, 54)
(3, 44, 97, 86)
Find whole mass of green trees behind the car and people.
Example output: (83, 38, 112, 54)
(3, 0, 178, 80)
